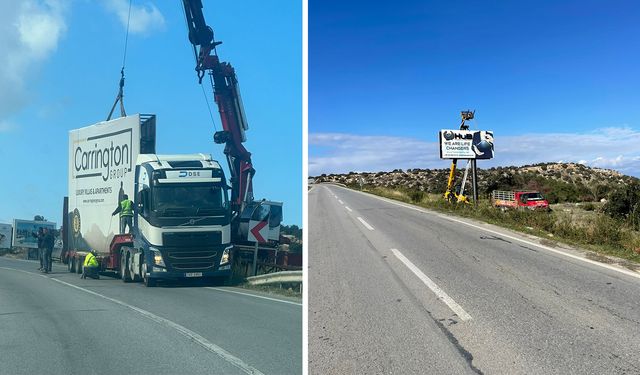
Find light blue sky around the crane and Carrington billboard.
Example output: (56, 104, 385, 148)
(0, 0, 303, 226)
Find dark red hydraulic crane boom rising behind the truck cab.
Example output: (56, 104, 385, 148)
(182, 0, 255, 212)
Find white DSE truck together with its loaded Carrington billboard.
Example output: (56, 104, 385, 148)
(63, 115, 232, 286)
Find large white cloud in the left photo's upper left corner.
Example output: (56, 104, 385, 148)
(0, 0, 67, 121)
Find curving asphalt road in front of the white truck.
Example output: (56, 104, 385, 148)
(0, 257, 302, 375)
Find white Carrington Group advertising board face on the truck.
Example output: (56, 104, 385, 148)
(68, 115, 140, 253)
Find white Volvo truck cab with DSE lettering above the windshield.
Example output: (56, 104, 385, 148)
(116, 154, 232, 286)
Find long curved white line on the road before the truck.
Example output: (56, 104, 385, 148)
(0, 267, 264, 375)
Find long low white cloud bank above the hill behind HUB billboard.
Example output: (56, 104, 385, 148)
(309, 126, 640, 176)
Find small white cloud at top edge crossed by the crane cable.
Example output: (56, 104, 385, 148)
(105, 0, 165, 35)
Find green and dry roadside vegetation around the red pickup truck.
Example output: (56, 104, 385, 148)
(349, 183, 640, 263)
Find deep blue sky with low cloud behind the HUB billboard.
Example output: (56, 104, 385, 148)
(309, 0, 640, 177)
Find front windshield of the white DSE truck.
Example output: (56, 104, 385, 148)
(152, 184, 226, 216)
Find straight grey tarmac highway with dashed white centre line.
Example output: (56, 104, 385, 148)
(308, 184, 640, 374)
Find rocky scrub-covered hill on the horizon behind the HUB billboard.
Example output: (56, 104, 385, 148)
(312, 162, 640, 203)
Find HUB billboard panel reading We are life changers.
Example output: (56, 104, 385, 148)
(440, 130, 493, 159)
